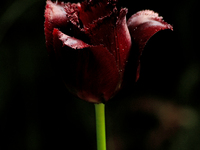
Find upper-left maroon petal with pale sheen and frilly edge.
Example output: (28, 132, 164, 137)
(44, 0, 79, 52)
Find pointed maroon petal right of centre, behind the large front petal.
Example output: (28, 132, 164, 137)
(86, 9, 131, 72)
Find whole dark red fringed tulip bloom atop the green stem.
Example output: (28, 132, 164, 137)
(44, 0, 172, 103)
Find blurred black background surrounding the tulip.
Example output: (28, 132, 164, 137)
(0, 0, 200, 150)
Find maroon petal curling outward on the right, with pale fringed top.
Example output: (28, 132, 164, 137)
(127, 10, 173, 81)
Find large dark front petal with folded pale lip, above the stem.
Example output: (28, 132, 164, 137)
(53, 29, 120, 103)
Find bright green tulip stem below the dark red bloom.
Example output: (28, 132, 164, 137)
(95, 103, 106, 150)
